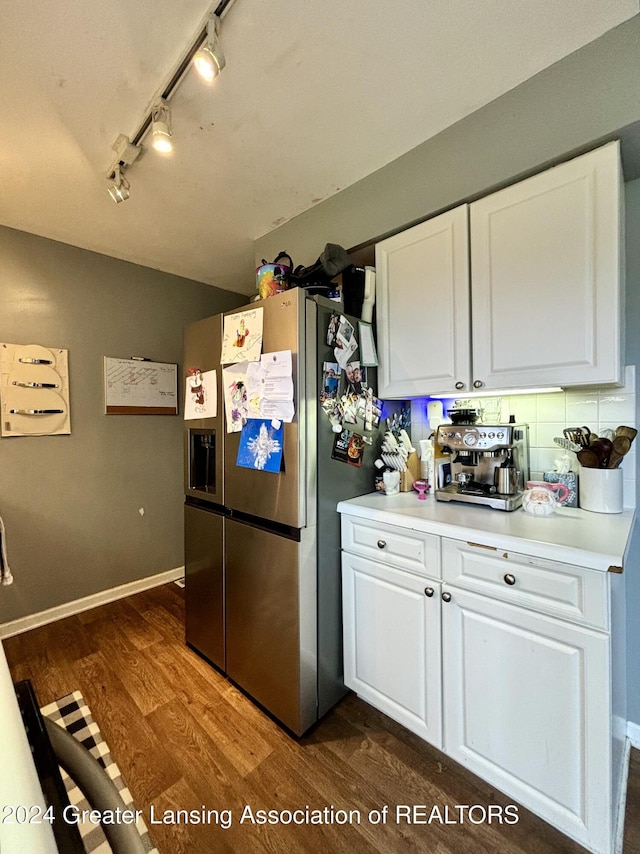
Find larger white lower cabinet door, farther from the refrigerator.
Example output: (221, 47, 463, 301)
(442, 585, 611, 852)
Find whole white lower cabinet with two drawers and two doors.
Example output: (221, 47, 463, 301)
(342, 515, 624, 854)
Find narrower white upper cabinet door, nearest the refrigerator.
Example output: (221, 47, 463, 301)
(376, 205, 470, 398)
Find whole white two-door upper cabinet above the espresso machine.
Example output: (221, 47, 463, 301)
(376, 142, 623, 398)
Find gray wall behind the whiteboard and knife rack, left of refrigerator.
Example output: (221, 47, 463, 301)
(0, 227, 246, 623)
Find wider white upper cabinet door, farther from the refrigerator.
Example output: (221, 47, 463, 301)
(470, 142, 622, 388)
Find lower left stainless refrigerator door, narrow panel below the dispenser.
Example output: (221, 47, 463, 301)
(184, 504, 225, 670)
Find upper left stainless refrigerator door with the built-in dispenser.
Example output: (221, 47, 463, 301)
(182, 314, 225, 505)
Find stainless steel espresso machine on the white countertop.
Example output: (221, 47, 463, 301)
(435, 424, 529, 510)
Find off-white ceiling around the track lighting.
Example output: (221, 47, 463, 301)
(0, 0, 638, 293)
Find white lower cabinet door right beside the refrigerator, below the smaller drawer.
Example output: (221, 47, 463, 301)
(342, 552, 442, 747)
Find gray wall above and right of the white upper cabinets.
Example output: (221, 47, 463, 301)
(255, 16, 640, 725)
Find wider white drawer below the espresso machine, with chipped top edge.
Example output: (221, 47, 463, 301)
(442, 539, 609, 630)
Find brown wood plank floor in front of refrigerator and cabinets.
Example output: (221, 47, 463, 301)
(4, 584, 640, 854)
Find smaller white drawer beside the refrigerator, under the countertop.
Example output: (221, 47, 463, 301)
(342, 515, 441, 578)
